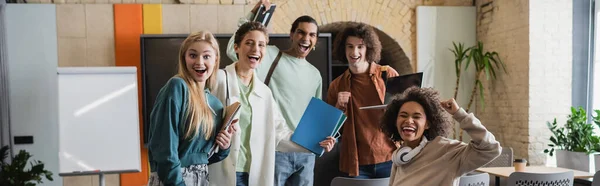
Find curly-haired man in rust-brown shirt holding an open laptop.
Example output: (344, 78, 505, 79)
(327, 23, 397, 178)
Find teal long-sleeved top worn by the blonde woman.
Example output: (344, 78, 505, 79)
(148, 77, 229, 186)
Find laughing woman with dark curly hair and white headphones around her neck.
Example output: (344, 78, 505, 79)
(381, 87, 502, 186)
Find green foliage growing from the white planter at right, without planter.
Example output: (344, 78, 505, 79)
(544, 107, 600, 156)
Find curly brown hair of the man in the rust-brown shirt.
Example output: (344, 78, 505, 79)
(333, 23, 381, 63)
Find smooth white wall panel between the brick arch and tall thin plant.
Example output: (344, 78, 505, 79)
(417, 6, 476, 141)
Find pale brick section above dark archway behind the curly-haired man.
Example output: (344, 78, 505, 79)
(268, 0, 422, 70)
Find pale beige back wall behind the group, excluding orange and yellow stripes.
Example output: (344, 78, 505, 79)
(44, 0, 472, 75)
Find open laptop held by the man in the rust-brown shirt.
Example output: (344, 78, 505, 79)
(360, 72, 423, 110)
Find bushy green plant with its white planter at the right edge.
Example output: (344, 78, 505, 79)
(544, 107, 600, 172)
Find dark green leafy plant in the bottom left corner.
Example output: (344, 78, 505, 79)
(0, 146, 53, 186)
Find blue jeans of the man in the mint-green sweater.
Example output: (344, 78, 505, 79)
(275, 152, 315, 186)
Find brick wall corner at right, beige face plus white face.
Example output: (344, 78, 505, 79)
(477, 0, 572, 165)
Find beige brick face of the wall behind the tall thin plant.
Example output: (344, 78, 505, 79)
(477, 0, 529, 163)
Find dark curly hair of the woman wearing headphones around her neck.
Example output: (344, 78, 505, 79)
(381, 87, 452, 142)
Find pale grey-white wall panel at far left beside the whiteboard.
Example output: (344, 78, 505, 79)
(5, 4, 62, 186)
